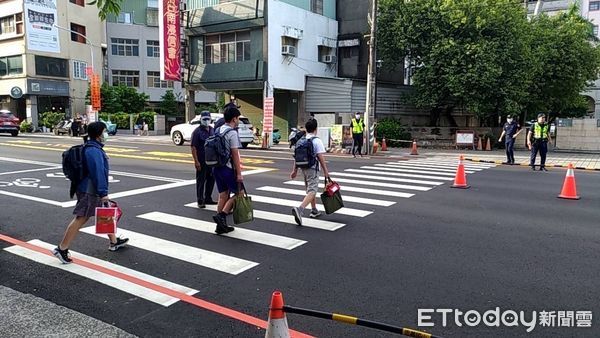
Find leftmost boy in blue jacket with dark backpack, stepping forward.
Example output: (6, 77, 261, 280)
(52, 122, 129, 264)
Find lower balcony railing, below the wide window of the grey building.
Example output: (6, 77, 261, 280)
(188, 60, 266, 84)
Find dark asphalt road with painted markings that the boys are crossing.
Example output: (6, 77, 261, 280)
(0, 136, 600, 337)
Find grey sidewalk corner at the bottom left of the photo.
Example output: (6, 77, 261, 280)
(0, 285, 135, 337)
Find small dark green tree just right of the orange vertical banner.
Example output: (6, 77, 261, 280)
(100, 82, 149, 114)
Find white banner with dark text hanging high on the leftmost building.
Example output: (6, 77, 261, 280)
(24, 0, 60, 53)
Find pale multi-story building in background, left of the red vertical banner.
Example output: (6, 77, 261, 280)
(104, 0, 216, 112)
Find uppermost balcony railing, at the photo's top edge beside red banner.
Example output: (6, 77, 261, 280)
(186, 0, 265, 28)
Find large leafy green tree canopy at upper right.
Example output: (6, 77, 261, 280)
(378, 0, 600, 124)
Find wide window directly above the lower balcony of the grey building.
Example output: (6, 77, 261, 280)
(204, 31, 251, 64)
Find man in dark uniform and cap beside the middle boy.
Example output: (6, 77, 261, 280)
(191, 111, 217, 208)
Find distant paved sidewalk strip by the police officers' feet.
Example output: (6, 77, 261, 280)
(386, 148, 600, 170)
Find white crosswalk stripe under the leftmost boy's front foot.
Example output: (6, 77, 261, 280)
(80, 226, 258, 275)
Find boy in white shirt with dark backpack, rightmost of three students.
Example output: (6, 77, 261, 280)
(290, 119, 329, 225)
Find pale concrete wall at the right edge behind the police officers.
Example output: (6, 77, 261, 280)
(556, 119, 600, 151)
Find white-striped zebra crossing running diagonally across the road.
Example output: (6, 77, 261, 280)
(4, 158, 495, 306)
